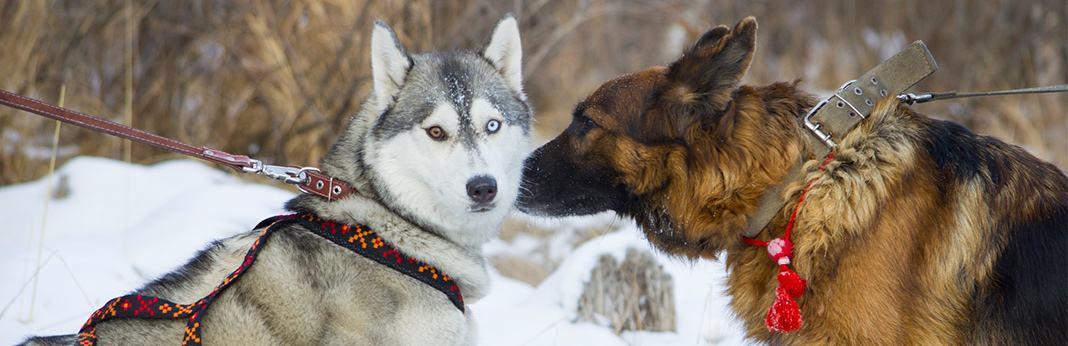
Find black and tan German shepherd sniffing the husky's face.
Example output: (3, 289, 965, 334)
(518, 17, 1068, 345)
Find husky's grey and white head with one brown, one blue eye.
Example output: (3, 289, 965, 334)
(301, 15, 531, 246)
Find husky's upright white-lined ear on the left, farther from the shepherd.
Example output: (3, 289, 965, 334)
(371, 20, 411, 107)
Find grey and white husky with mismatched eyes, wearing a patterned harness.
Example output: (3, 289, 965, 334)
(26, 15, 532, 345)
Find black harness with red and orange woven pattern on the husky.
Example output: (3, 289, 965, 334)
(78, 214, 465, 346)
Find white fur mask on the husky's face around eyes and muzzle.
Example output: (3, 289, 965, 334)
(366, 98, 529, 245)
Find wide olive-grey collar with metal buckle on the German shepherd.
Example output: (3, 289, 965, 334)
(742, 41, 938, 238)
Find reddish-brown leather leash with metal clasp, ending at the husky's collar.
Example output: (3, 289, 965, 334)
(0, 90, 355, 200)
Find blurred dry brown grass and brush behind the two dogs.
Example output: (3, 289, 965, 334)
(0, 0, 1068, 185)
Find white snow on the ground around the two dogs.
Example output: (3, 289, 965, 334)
(0, 157, 744, 346)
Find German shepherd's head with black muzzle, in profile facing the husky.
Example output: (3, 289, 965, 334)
(518, 17, 815, 258)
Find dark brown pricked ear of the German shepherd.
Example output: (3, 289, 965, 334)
(665, 17, 756, 115)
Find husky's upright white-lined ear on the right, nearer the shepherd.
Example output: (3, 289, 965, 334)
(482, 13, 527, 98)
